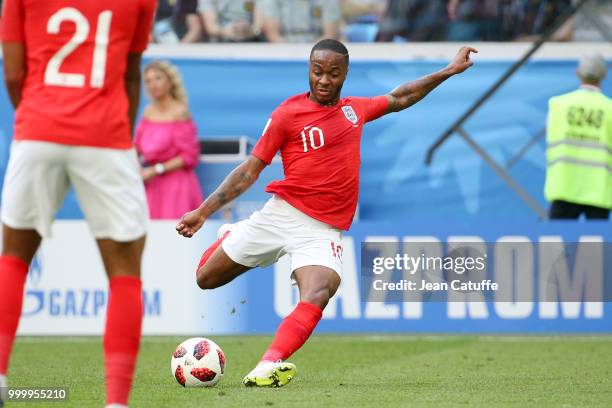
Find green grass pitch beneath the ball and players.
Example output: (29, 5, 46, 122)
(7, 335, 612, 408)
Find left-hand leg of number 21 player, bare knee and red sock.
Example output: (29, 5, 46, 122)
(0, 225, 41, 407)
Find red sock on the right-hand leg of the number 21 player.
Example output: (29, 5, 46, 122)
(104, 276, 143, 405)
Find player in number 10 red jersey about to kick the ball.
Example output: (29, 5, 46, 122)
(176, 39, 477, 387)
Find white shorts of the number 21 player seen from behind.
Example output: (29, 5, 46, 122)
(2, 140, 149, 242)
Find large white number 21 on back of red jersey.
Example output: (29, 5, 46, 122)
(45, 7, 113, 88)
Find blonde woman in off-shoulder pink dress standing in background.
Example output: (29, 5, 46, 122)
(134, 61, 203, 219)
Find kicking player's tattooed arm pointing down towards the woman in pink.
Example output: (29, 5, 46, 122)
(176, 156, 266, 238)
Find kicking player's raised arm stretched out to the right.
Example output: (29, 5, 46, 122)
(386, 47, 478, 113)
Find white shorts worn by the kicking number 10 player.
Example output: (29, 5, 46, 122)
(221, 196, 342, 277)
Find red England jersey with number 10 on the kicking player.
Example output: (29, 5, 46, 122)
(253, 93, 389, 230)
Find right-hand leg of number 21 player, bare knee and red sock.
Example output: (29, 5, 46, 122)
(98, 237, 145, 407)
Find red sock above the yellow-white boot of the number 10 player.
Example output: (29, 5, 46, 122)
(261, 302, 323, 361)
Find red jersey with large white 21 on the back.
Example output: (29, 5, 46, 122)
(2, 0, 156, 149)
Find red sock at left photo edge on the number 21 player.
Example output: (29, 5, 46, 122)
(0, 255, 29, 375)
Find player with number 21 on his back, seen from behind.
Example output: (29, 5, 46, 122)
(0, 0, 156, 407)
